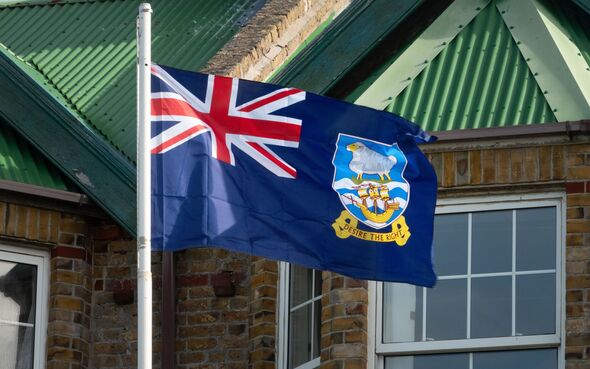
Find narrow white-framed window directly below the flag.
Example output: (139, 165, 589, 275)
(278, 263, 322, 369)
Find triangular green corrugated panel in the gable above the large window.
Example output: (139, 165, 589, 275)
(387, 2, 556, 131)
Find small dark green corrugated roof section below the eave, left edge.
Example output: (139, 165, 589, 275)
(0, 120, 68, 190)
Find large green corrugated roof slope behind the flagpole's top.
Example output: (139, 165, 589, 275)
(0, 0, 263, 160)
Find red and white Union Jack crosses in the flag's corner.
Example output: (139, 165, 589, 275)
(151, 65, 305, 178)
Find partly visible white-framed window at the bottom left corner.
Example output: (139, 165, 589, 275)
(0, 245, 49, 369)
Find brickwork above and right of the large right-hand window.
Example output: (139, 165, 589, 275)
(428, 143, 590, 369)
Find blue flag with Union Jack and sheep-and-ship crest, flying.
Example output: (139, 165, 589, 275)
(151, 65, 436, 287)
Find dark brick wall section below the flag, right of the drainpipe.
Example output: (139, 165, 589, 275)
(175, 248, 250, 369)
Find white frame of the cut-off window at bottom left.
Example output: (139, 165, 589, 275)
(0, 244, 50, 369)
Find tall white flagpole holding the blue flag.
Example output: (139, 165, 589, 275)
(137, 3, 152, 369)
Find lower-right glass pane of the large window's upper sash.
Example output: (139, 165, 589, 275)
(516, 273, 555, 335)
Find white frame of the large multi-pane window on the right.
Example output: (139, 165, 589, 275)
(367, 192, 566, 369)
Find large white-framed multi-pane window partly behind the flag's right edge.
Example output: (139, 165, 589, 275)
(375, 195, 563, 369)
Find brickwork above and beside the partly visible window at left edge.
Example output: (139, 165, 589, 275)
(0, 203, 92, 369)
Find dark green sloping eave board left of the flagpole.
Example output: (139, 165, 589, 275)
(0, 52, 136, 235)
